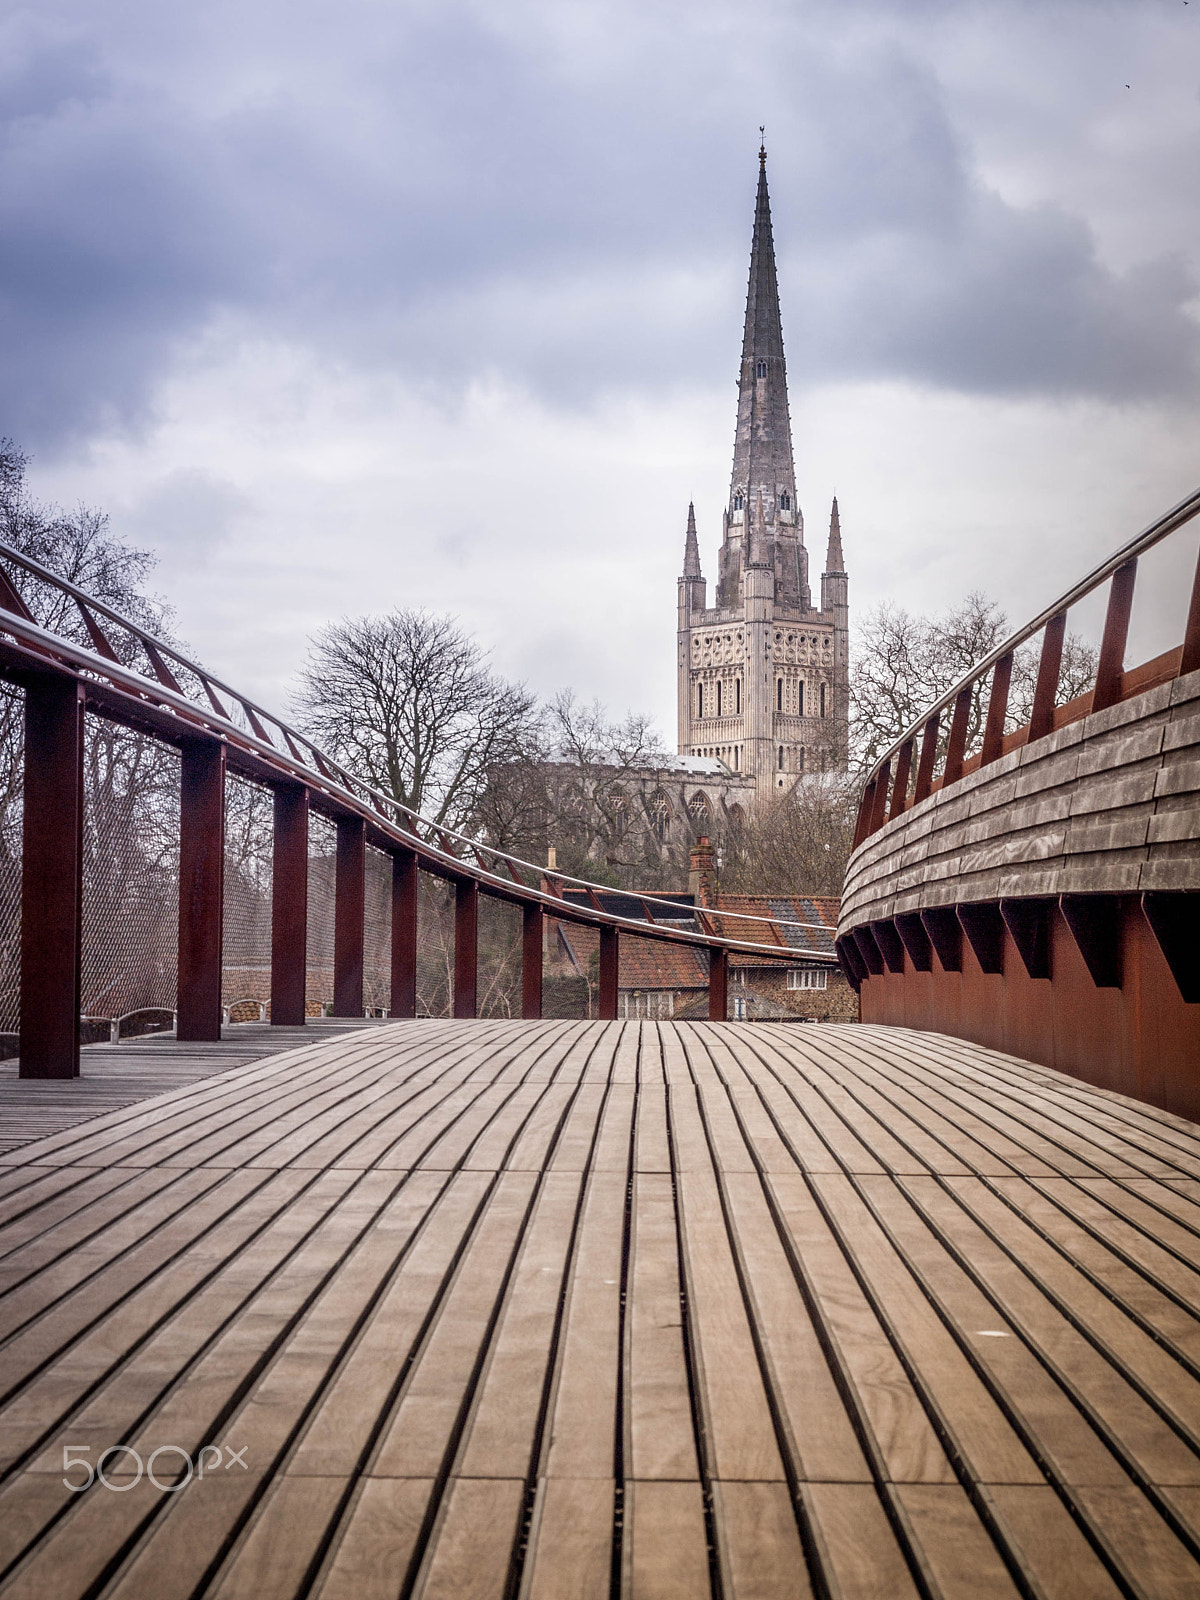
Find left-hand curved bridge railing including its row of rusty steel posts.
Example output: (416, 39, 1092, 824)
(0, 544, 837, 1077)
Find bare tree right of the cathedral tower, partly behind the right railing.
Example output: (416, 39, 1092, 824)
(850, 592, 1096, 773)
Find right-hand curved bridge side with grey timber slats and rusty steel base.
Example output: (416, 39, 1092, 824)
(837, 490, 1200, 1117)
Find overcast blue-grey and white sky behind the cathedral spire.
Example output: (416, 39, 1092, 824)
(0, 0, 1200, 738)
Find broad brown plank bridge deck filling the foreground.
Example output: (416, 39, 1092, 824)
(0, 1022, 1200, 1600)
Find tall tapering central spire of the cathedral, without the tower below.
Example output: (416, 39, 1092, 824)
(730, 146, 795, 523)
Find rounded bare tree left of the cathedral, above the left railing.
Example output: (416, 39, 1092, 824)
(293, 611, 534, 827)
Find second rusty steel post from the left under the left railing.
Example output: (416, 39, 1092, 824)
(176, 739, 226, 1042)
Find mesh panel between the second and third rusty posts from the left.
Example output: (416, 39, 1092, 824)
(221, 778, 274, 1022)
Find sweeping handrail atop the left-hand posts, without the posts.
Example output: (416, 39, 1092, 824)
(0, 563, 837, 965)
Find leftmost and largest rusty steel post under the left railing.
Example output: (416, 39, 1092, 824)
(19, 678, 83, 1078)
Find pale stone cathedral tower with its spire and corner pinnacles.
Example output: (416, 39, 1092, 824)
(678, 140, 850, 794)
